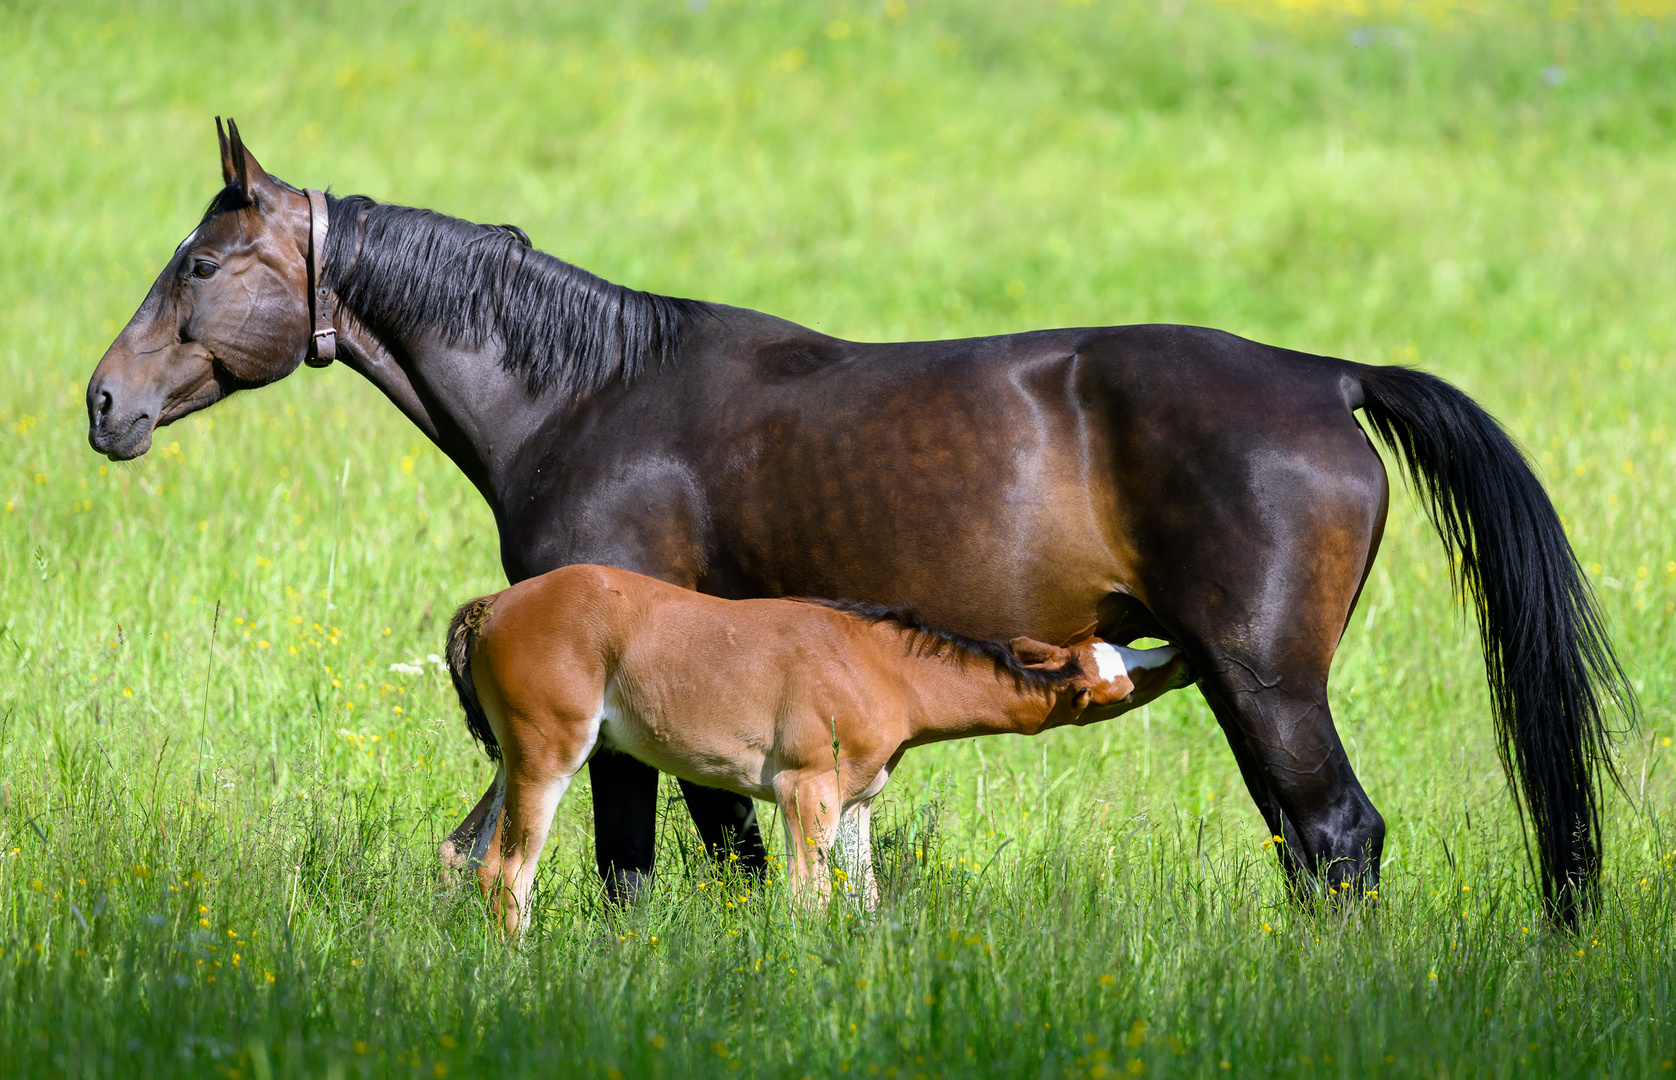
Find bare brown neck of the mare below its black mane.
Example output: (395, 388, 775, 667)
(337, 296, 558, 520)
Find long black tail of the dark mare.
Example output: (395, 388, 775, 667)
(1358, 367, 1636, 924)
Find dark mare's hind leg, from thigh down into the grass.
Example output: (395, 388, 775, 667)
(1148, 433, 1386, 890)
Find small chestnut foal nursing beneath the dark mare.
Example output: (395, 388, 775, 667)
(447, 565, 1192, 932)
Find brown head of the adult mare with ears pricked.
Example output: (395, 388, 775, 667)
(87, 119, 312, 461)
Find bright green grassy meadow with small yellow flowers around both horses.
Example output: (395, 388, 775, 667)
(0, 0, 1676, 1080)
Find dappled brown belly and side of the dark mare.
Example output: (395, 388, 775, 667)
(701, 357, 1131, 641)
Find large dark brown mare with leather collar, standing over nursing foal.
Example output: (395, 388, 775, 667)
(87, 131, 1632, 919)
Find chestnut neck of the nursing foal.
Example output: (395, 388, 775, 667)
(902, 644, 1061, 745)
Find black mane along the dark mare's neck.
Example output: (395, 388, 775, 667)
(323, 195, 707, 401)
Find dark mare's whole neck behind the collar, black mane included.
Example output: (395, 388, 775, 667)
(325, 196, 697, 530)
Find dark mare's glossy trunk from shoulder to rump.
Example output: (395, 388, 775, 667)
(503, 309, 1383, 642)
